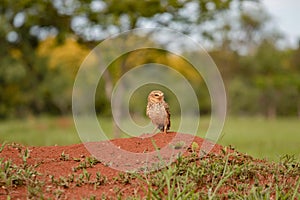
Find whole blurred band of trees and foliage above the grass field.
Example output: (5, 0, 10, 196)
(0, 0, 300, 118)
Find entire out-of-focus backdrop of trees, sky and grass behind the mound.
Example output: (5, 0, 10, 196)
(0, 0, 300, 160)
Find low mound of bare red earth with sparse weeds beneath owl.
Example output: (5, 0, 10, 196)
(0, 132, 300, 199)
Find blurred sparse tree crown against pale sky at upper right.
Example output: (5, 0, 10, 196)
(211, 1, 282, 55)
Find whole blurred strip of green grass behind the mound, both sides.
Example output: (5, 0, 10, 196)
(0, 117, 300, 161)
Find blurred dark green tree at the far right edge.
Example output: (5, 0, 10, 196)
(239, 41, 300, 118)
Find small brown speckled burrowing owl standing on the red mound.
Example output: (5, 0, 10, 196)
(146, 90, 171, 133)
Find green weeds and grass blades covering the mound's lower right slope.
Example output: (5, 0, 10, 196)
(136, 148, 300, 199)
